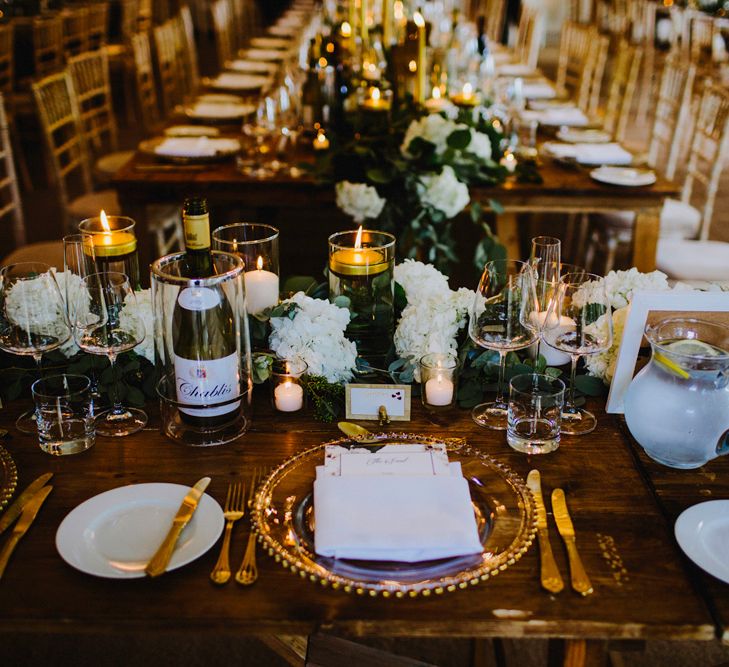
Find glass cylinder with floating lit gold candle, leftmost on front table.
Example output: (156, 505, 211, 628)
(78, 214, 140, 289)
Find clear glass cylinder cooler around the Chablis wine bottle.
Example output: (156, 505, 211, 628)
(152, 251, 253, 446)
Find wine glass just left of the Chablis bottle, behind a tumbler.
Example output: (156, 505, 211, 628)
(73, 271, 147, 436)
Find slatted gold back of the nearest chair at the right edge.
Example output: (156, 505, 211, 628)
(681, 83, 729, 241)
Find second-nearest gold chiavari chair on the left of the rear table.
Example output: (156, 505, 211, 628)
(32, 71, 121, 234)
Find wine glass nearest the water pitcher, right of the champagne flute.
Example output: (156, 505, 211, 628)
(542, 272, 613, 435)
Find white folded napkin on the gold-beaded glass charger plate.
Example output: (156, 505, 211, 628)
(314, 470, 482, 563)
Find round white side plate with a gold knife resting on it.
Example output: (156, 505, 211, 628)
(56, 483, 225, 579)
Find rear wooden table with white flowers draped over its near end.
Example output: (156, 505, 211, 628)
(114, 154, 677, 282)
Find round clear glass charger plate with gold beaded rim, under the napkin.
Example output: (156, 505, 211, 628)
(252, 433, 536, 597)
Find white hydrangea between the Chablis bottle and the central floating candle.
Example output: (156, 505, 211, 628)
(269, 292, 357, 382)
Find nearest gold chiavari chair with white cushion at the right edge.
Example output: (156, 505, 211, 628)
(656, 83, 729, 281)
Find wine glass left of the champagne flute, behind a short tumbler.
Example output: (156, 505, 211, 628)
(468, 259, 539, 430)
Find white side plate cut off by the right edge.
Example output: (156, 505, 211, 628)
(674, 500, 729, 584)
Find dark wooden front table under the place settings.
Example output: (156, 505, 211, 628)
(0, 388, 729, 665)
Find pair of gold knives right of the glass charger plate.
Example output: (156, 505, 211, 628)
(527, 470, 593, 596)
